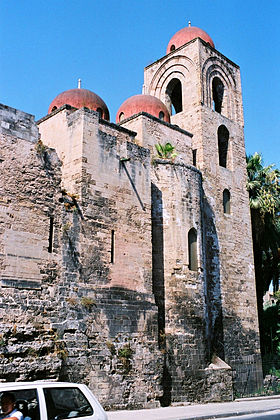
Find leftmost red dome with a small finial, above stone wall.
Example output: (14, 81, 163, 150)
(48, 89, 110, 120)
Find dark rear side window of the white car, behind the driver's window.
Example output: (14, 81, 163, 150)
(44, 387, 93, 420)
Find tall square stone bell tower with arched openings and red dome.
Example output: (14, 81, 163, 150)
(143, 23, 262, 392)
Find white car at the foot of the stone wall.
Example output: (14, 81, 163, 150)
(0, 381, 108, 420)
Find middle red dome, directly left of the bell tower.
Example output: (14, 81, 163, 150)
(116, 95, 170, 123)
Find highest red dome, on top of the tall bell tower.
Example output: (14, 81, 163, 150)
(166, 26, 215, 54)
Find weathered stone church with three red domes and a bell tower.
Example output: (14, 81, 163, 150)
(0, 27, 262, 409)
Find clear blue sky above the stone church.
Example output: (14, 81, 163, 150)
(0, 0, 280, 168)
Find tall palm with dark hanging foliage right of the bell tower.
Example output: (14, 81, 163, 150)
(247, 153, 280, 301)
